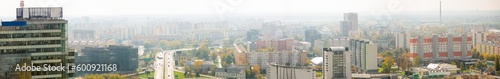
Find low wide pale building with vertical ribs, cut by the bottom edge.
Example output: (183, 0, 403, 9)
(266, 65, 316, 79)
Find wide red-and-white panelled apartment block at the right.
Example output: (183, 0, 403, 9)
(409, 34, 472, 63)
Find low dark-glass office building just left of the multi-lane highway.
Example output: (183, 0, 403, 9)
(76, 45, 139, 75)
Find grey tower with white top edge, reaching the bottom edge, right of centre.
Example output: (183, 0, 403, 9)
(323, 47, 351, 79)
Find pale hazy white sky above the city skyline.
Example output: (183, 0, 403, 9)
(0, 0, 500, 17)
